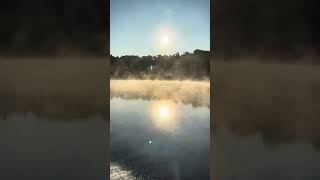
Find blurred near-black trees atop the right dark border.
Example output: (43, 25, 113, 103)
(211, 0, 320, 59)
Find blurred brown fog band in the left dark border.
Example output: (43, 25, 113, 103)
(0, 57, 109, 117)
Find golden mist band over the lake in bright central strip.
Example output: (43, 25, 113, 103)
(110, 80, 210, 107)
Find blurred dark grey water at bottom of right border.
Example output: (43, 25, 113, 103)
(212, 128, 320, 180)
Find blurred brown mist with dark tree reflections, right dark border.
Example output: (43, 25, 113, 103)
(212, 63, 320, 150)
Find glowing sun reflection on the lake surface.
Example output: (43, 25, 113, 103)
(150, 100, 178, 131)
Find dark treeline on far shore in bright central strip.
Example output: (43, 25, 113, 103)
(110, 49, 210, 79)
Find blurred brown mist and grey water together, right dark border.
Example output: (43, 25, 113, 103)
(211, 60, 320, 180)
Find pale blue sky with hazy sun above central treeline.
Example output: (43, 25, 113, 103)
(110, 0, 210, 56)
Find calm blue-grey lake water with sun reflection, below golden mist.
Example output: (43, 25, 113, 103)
(110, 98, 210, 180)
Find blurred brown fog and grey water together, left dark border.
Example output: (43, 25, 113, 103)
(0, 57, 109, 180)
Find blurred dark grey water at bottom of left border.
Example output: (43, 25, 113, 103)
(0, 113, 108, 180)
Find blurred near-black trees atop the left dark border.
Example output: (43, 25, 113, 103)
(0, 0, 109, 57)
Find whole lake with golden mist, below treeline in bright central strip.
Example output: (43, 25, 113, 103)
(110, 80, 210, 179)
